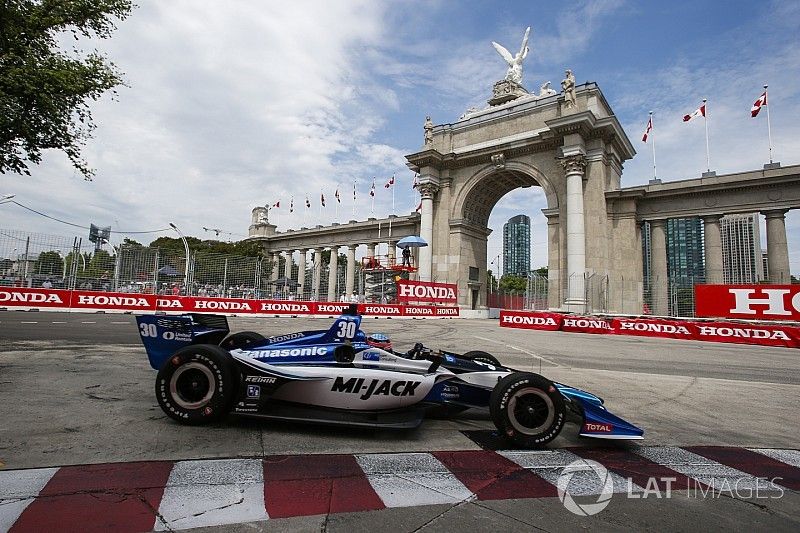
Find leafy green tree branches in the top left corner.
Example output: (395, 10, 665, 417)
(0, 0, 134, 180)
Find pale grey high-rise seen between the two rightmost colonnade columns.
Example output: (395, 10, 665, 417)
(720, 213, 765, 283)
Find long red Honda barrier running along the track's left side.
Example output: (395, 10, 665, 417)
(0, 287, 459, 317)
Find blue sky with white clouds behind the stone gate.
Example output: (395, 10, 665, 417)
(0, 0, 800, 273)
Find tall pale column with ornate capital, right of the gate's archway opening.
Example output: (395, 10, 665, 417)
(561, 154, 586, 311)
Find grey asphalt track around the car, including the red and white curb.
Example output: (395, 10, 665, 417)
(0, 312, 800, 532)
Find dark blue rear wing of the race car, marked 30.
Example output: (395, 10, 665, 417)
(136, 313, 230, 370)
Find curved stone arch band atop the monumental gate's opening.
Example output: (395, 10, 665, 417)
(449, 161, 559, 227)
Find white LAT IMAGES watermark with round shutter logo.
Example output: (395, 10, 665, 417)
(556, 459, 784, 516)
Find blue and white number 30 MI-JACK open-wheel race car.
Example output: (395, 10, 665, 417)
(137, 306, 643, 448)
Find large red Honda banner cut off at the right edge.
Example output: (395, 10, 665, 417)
(694, 285, 800, 320)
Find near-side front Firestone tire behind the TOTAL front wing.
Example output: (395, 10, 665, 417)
(489, 372, 567, 448)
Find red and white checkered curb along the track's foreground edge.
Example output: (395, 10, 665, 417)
(0, 446, 800, 533)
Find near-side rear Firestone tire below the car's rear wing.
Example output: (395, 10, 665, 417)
(156, 344, 239, 425)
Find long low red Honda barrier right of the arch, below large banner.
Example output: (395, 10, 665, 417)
(500, 310, 800, 348)
